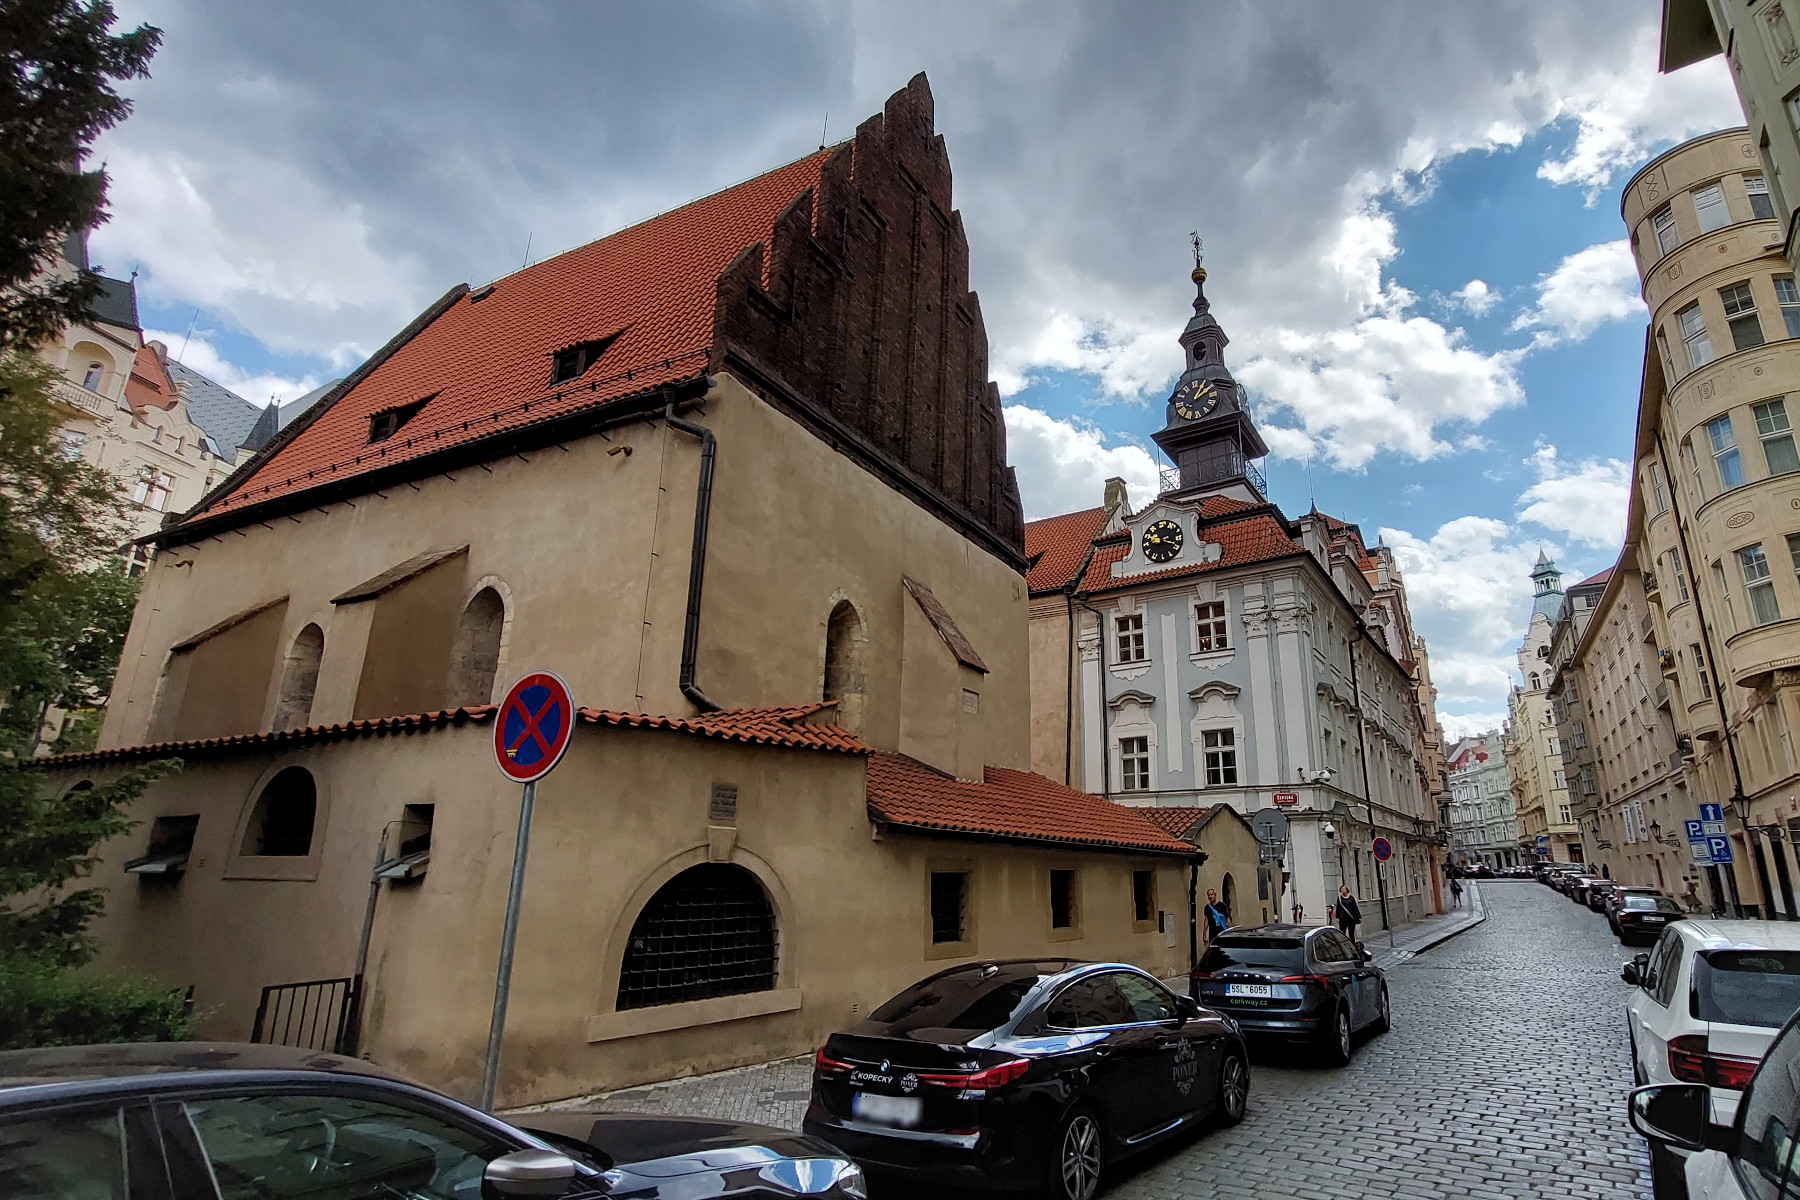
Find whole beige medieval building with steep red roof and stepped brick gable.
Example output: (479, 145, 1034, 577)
(45, 76, 1242, 1105)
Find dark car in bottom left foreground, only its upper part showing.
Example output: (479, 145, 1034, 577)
(0, 1042, 866, 1200)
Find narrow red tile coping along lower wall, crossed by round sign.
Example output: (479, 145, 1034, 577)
(31, 703, 869, 766)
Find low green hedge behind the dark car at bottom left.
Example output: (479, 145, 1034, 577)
(0, 961, 194, 1051)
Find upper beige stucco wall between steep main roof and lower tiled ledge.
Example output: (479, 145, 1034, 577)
(101, 376, 1030, 774)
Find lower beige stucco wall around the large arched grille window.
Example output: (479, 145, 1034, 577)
(56, 725, 1180, 1105)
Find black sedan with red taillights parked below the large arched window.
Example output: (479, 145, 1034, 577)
(805, 959, 1249, 1200)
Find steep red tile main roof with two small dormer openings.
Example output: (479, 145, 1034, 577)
(189, 148, 835, 520)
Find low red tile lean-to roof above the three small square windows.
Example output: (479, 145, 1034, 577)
(868, 754, 1193, 855)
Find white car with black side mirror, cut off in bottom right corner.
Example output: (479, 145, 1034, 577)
(1629, 1016, 1800, 1200)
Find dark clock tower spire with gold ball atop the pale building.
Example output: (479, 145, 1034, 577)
(1152, 255, 1269, 504)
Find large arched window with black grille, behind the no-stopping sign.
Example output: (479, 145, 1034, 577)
(617, 862, 776, 1011)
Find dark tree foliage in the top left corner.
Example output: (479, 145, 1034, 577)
(0, 0, 162, 351)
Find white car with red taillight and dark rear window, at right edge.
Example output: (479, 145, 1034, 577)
(1620, 919, 1800, 1124)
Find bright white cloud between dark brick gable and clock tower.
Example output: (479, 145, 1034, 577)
(1006, 405, 1161, 520)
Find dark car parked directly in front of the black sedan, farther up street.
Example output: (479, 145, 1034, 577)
(1192, 925, 1393, 1067)
